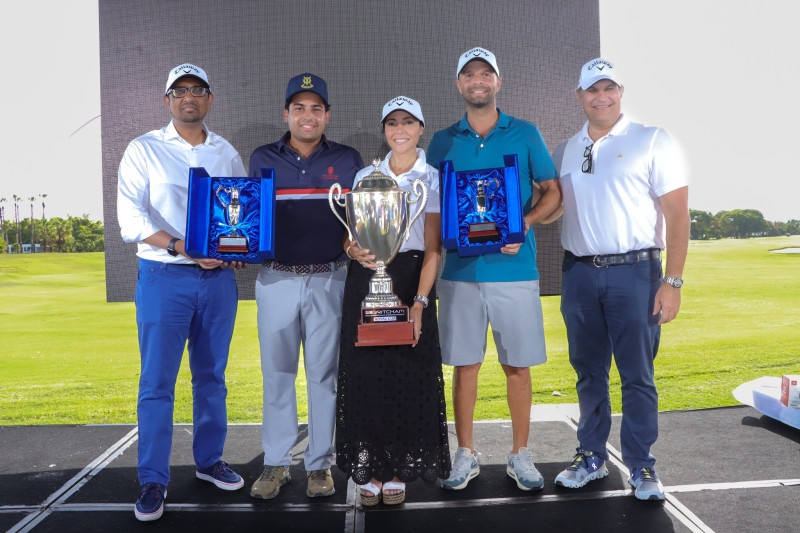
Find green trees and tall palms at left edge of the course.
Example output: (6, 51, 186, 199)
(0, 194, 105, 253)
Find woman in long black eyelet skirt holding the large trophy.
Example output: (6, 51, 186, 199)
(332, 96, 450, 506)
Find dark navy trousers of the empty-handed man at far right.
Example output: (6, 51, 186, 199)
(561, 252, 662, 469)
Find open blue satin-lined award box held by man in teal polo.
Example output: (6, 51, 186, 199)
(439, 154, 525, 256)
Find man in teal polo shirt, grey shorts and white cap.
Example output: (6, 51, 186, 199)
(428, 48, 561, 490)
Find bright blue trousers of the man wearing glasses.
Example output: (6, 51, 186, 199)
(136, 259, 238, 485)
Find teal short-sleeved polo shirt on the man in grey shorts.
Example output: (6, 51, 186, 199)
(426, 109, 557, 281)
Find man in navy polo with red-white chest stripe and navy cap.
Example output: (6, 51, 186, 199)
(250, 73, 364, 499)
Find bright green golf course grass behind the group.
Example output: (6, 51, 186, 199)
(0, 236, 800, 425)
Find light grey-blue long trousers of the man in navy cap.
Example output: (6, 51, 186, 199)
(256, 267, 347, 471)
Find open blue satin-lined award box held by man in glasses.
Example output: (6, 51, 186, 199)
(186, 167, 275, 263)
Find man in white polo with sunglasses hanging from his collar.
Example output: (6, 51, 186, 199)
(551, 58, 690, 500)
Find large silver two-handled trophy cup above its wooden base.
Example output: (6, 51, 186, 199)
(328, 159, 428, 308)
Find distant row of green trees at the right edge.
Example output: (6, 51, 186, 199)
(689, 209, 800, 240)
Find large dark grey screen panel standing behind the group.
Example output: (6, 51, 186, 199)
(99, 0, 600, 302)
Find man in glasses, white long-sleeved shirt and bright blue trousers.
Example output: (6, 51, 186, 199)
(117, 63, 247, 521)
